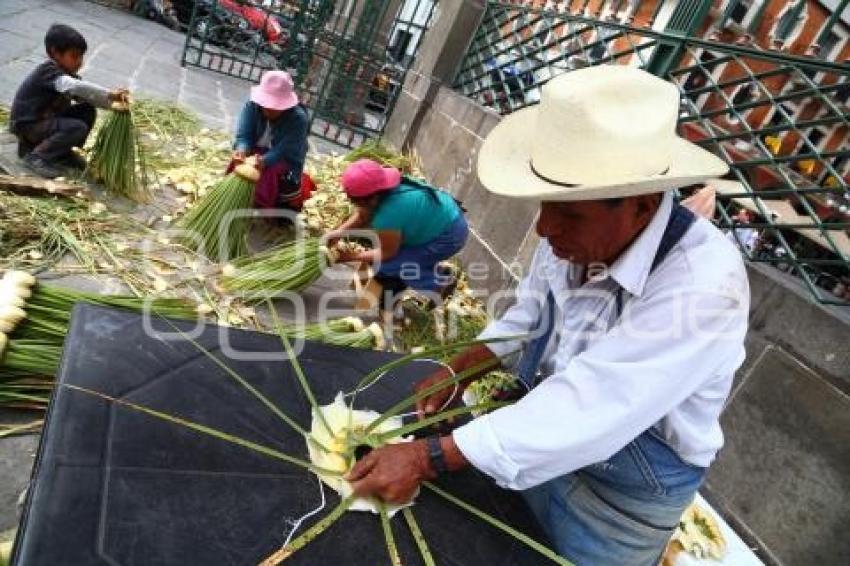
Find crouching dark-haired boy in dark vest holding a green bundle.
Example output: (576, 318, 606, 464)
(9, 24, 128, 179)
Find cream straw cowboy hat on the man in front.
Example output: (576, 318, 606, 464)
(478, 65, 728, 201)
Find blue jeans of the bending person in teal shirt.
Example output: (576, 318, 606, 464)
(377, 213, 469, 291)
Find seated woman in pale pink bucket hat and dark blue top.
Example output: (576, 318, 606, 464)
(227, 71, 314, 210)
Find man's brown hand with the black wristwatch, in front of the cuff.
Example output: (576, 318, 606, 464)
(345, 440, 437, 504)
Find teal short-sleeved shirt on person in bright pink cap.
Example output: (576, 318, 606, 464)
(370, 179, 460, 246)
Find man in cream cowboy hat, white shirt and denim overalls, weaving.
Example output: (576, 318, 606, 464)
(348, 66, 749, 565)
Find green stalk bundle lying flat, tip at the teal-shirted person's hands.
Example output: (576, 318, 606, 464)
(222, 238, 336, 301)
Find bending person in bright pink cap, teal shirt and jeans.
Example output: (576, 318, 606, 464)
(328, 159, 469, 307)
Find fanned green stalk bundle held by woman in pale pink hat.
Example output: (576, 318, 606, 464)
(180, 163, 260, 260)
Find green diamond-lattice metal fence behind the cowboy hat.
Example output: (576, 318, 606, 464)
(454, 1, 850, 305)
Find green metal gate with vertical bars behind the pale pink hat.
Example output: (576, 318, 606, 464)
(182, 0, 436, 147)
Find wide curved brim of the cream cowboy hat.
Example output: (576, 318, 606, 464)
(478, 106, 728, 201)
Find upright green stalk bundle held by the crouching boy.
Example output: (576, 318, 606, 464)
(87, 103, 150, 202)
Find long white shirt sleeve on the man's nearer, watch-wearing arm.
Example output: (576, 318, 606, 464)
(454, 284, 749, 489)
